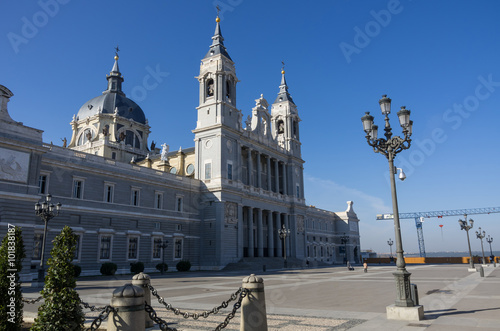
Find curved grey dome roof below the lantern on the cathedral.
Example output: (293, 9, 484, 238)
(77, 93, 146, 124)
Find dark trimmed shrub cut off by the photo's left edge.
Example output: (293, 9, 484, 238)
(0, 224, 26, 330)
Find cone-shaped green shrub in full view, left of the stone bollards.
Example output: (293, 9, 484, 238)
(31, 226, 85, 331)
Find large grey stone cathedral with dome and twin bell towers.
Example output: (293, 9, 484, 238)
(0, 16, 360, 281)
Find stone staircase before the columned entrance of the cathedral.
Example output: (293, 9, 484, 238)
(223, 257, 306, 274)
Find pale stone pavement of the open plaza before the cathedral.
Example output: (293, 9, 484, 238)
(23, 265, 500, 331)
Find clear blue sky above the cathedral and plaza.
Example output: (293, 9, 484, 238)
(0, 0, 500, 253)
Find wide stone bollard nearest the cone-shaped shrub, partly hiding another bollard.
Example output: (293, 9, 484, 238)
(108, 284, 146, 331)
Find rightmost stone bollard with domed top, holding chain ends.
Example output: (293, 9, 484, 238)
(240, 274, 267, 331)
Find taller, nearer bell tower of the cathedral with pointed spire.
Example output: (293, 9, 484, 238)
(193, 13, 242, 184)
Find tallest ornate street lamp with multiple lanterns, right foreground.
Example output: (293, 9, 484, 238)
(361, 95, 415, 307)
